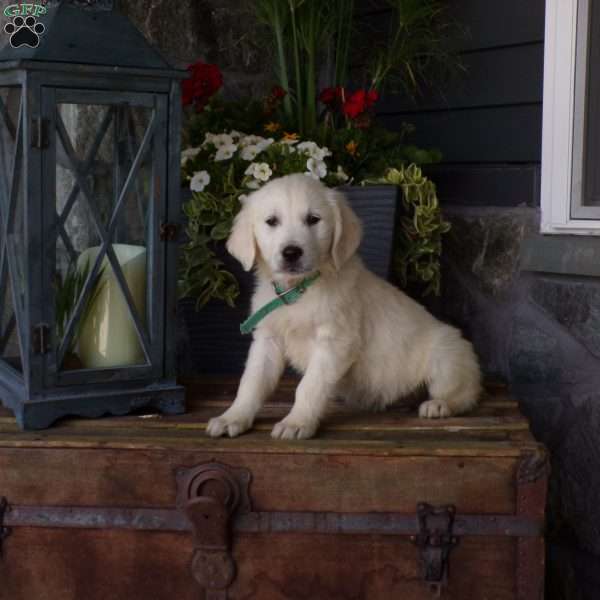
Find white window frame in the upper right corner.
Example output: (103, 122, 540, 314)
(541, 0, 600, 235)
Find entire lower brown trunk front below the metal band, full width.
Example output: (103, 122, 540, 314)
(0, 528, 515, 600)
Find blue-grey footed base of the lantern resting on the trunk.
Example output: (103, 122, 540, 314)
(0, 381, 185, 430)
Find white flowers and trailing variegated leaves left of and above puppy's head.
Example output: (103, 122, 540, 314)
(179, 130, 350, 307)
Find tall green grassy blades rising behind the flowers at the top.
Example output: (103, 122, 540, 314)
(254, 0, 462, 139)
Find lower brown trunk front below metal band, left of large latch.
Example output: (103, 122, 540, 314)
(0, 527, 195, 600)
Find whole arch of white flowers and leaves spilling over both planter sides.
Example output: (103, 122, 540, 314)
(179, 128, 449, 307)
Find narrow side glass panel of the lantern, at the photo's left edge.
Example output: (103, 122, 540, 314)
(0, 86, 26, 371)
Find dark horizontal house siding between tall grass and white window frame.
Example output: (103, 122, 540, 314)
(376, 0, 544, 206)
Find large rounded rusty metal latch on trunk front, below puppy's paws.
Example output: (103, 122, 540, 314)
(177, 462, 251, 600)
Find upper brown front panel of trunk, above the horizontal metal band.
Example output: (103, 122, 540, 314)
(0, 442, 518, 514)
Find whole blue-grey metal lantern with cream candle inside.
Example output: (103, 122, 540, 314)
(0, 3, 185, 429)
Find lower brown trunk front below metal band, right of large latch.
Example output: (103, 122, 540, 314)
(231, 535, 514, 600)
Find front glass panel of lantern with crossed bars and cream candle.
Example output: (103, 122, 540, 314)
(55, 103, 154, 370)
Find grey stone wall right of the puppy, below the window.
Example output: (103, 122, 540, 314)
(439, 206, 600, 600)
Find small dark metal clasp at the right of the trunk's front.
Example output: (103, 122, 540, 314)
(411, 502, 458, 597)
